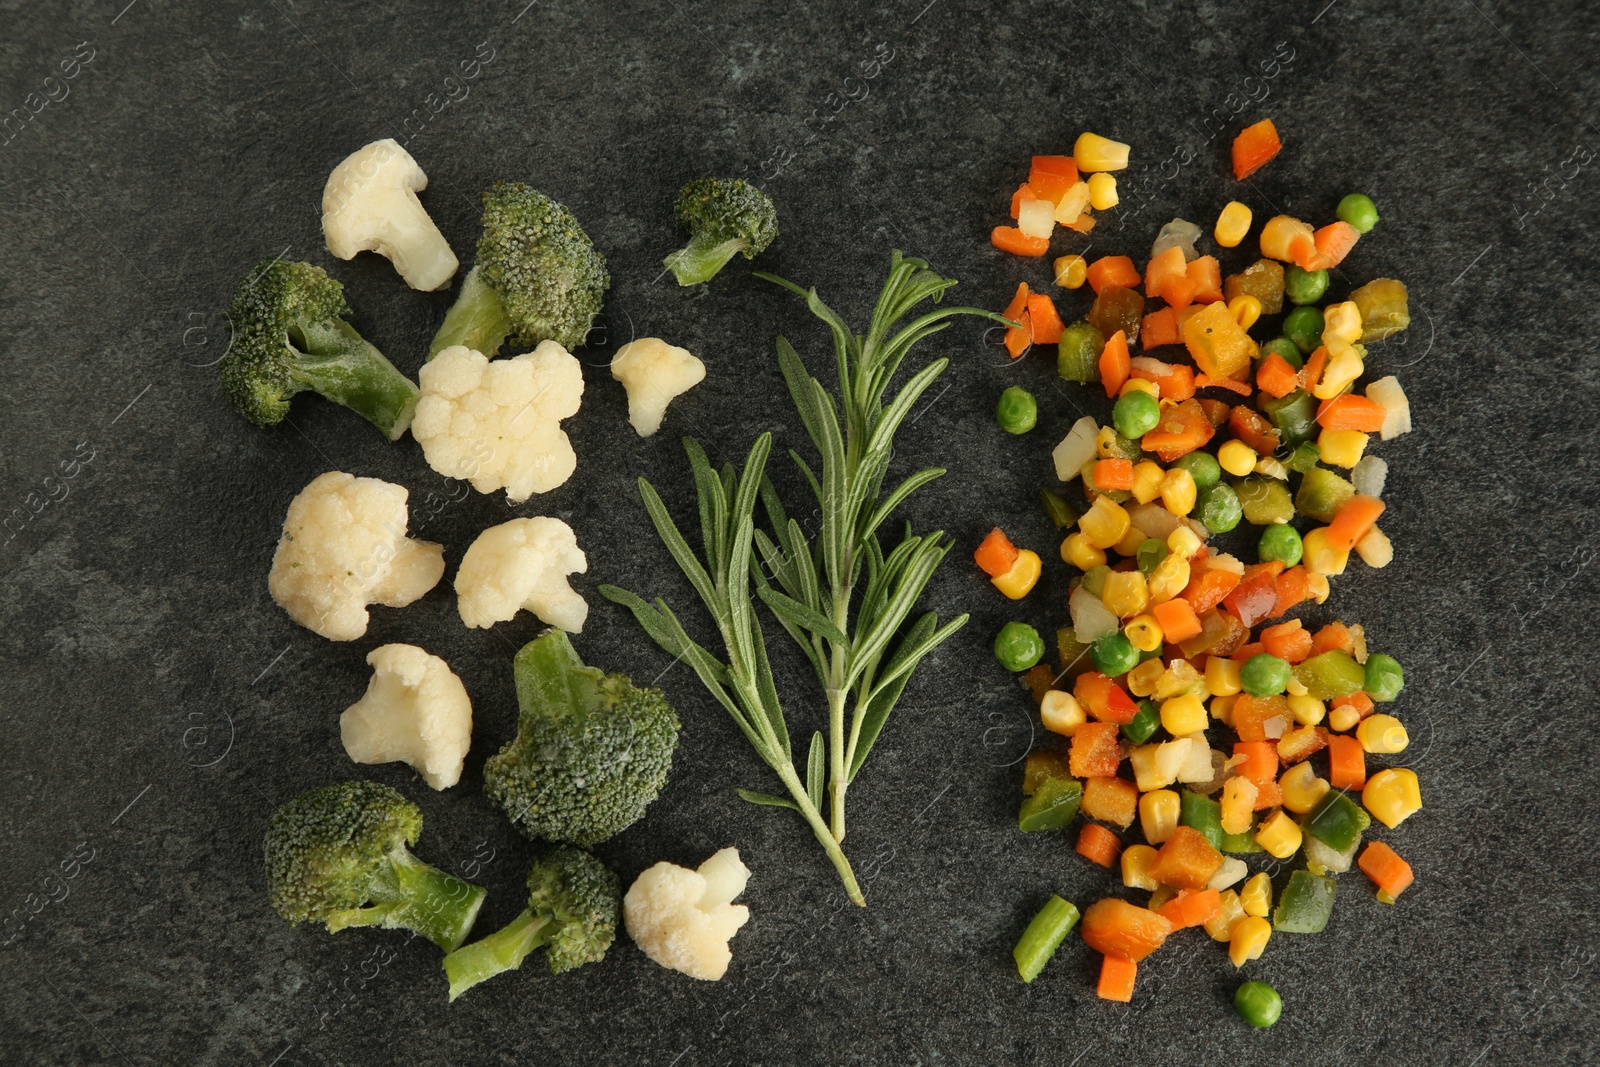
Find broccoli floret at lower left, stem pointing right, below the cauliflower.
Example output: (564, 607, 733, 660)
(266, 782, 485, 952)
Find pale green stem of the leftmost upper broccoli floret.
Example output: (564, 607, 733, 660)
(290, 318, 418, 442)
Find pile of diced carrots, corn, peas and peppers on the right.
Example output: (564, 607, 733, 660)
(974, 122, 1422, 1025)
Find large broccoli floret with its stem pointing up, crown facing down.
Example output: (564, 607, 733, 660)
(483, 630, 678, 848)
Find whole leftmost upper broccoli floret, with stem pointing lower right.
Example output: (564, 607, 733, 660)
(228, 259, 418, 440)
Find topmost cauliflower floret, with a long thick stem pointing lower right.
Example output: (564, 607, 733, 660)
(322, 138, 461, 290)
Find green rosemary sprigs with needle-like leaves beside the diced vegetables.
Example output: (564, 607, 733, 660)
(600, 251, 1005, 904)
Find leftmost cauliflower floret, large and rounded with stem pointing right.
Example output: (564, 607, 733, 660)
(267, 470, 445, 641)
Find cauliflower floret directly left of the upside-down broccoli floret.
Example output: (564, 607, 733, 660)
(339, 645, 472, 789)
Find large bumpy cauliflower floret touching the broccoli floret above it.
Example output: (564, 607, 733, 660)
(411, 341, 584, 504)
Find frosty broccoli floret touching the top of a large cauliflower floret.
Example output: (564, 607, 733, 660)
(429, 181, 611, 358)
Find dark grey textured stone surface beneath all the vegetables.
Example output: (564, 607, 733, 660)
(0, 0, 1600, 1067)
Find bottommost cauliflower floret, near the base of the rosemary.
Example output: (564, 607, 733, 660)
(622, 848, 750, 982)
